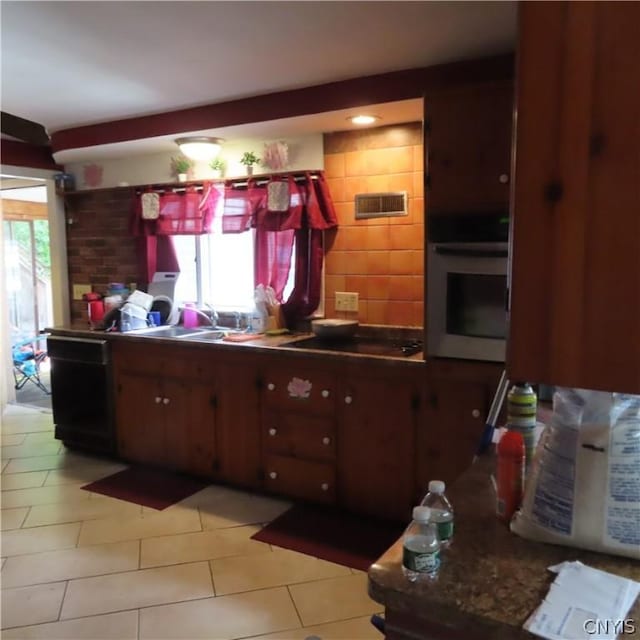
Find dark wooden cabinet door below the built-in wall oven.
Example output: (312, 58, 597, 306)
(416, 380, 489, 490)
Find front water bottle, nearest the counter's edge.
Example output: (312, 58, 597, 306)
(402, 506, 440, 582)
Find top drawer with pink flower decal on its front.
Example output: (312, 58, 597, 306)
(264, 362, 335, 415)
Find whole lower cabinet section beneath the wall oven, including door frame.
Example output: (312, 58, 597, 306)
(415, 360, 502, 492)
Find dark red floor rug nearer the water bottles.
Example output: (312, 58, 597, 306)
(251, 505, 405, 571)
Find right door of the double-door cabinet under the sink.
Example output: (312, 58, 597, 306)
(163, 379, 217, 477)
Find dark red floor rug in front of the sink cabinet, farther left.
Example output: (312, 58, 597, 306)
(82, 467, 209, 510)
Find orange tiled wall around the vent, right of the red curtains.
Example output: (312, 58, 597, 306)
(324, 122, 424, 326)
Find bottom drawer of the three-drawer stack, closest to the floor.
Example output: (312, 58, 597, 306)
(264, 455, 336, 503)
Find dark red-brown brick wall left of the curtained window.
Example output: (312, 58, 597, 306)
(66, 188, 139, 324)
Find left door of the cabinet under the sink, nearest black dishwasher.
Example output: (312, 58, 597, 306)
(116, 372, 166, 466)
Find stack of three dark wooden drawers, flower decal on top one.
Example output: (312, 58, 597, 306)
(261, 358, 337, 504)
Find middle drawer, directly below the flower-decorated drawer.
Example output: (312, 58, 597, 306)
(262, 410, 336, 460)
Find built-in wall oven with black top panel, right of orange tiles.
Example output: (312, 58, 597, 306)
(427, 214, 508, 362)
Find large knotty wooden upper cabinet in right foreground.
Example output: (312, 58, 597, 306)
(508, 2, 640, 393)
